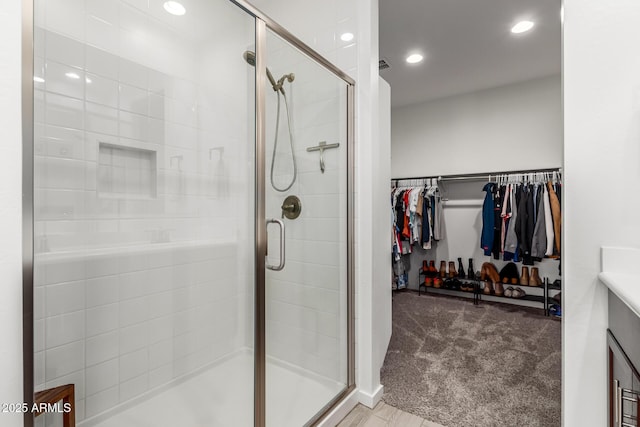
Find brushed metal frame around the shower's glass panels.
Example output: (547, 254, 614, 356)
(21, 0, 355, 427)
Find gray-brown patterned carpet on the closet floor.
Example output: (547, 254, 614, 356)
(381, 291, 562, 427)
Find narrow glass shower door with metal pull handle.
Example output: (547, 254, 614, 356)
(265, 31, 348, 427)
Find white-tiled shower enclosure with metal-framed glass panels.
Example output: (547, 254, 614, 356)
(25, 0, 354, 427)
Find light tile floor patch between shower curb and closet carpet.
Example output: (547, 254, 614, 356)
(338, 401, 443, 427)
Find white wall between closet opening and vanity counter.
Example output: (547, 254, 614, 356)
(563, 0, 640, 427)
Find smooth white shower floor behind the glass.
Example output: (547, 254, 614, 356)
(86, 352, 344, 427)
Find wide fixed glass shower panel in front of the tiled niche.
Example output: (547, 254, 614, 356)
(33, 0, 256, 427)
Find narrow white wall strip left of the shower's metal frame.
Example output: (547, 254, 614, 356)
(0, 0, 23, 427)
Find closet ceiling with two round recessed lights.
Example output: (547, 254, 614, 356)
(379, 0, 561, 107)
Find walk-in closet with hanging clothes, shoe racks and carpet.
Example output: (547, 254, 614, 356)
(380, 0, 570, 427)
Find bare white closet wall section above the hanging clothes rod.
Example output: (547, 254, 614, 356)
(391, 76, 562, 177)
